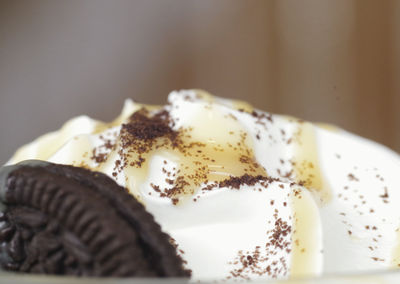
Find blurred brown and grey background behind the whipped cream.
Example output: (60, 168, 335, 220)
(0, 0, 400, 164)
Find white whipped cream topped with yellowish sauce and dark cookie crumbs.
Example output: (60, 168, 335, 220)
(8, 90, 400, 280)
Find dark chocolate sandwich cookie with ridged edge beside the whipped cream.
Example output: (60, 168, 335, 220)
(0, 161, 190, 277)
